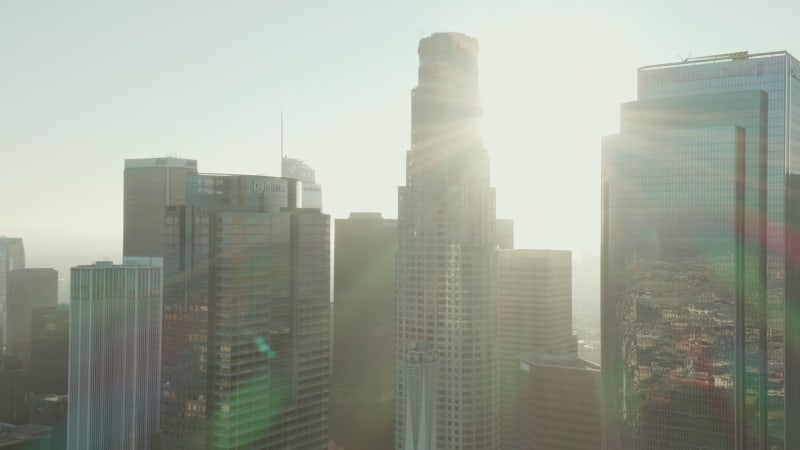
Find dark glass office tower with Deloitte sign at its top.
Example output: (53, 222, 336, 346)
(161, 174, 330, 450)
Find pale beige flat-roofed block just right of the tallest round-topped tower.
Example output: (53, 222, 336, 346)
(497, 249, 578, 448)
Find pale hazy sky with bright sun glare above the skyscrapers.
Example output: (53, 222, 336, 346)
(0, 0, 800, 282)
